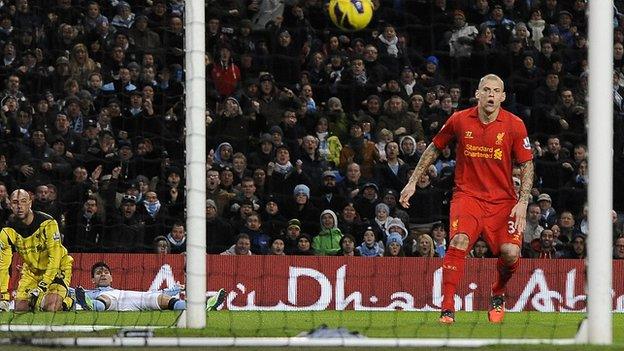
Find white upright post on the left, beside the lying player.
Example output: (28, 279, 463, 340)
(184, 0, 206, 328)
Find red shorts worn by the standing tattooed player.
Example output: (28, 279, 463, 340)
(449, 195, 522, 256)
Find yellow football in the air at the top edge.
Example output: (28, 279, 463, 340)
(328, 0, 373, 32)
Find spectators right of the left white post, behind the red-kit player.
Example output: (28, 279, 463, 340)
(206, 0, 624, 258)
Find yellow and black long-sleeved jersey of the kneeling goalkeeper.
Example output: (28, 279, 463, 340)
(0, 211, 71, 300)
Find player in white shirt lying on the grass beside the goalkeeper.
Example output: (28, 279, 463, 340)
(76, 262, 226, 311)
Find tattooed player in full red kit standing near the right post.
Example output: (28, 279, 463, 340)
(400, 74, 534, 324)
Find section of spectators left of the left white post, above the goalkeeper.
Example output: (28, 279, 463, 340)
(0, 0, 185, 252)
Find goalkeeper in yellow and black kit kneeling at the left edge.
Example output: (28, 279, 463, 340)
(0, 189, 73, 311)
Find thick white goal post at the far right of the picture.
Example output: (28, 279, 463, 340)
(587, 0, 613, 344)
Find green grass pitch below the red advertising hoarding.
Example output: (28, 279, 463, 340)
(0, 311, 624, 351)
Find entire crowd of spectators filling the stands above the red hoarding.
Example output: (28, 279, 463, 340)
(0, 0, 624, 258)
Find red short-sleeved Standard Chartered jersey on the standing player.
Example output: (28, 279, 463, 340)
(433, 107, 533, 202)
